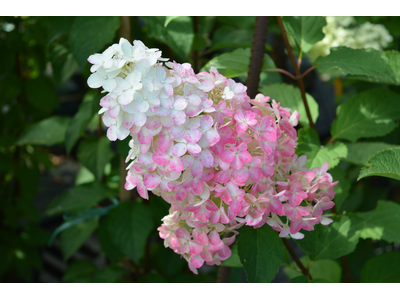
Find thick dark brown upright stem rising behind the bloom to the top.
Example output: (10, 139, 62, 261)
(246, 17, 269, 99)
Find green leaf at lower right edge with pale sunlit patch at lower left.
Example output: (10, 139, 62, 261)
(352, 200, 400, 243)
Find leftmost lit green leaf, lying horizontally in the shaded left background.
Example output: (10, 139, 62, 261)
(17, 116, 71, 146)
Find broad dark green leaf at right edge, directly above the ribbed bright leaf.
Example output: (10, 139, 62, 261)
(331, 89, 400, 142)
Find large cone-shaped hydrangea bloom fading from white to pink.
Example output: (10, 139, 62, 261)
(88, 39, 337, 274)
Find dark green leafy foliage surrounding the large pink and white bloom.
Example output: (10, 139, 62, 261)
(0, 16, 400, 283)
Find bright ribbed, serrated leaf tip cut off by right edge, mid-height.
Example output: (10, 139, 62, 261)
(357, 148, 400, 180)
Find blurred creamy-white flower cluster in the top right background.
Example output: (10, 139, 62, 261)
(308, 17, 393, 61)
